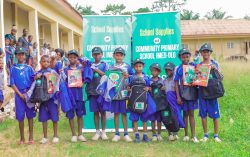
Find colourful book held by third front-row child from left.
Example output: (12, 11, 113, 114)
(68, 70, 83, 87)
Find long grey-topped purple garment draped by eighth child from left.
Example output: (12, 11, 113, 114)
(164, 78, 185, 128)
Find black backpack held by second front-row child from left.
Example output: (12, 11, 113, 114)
(30, 75, 50, 103)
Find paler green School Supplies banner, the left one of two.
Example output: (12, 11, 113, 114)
(83, 15, 132, 131)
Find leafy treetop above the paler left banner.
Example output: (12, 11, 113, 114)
(101, 4, 126, 15)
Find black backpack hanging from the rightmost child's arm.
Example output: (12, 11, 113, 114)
(199, 69, 225, 99)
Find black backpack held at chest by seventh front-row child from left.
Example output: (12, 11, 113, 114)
(150, 82, 168, 111)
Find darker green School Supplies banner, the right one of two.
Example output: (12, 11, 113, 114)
(132, 12, 181, 78)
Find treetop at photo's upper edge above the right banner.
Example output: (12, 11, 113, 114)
(152, 0, 187, 12)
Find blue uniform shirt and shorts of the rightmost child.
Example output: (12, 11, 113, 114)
(199, 60, 220, 119)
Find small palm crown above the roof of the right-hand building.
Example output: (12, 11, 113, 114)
(204, 8, 232, 20)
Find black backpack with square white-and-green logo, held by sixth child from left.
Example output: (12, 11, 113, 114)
(128, 77, 148, 114)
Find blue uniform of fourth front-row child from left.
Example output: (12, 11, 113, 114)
(87, 62, 108, 112)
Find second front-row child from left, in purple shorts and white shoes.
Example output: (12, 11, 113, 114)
(36, 55, 59, 144)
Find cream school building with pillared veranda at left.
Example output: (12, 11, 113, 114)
(0, 0, 83, 52)
